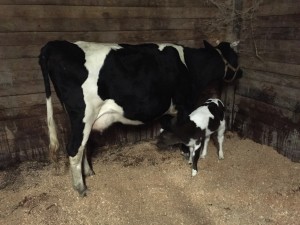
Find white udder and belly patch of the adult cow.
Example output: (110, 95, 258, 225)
(93, 99, 143, 132)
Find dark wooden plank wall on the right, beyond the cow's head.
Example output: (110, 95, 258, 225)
(232, 0, 300, 161)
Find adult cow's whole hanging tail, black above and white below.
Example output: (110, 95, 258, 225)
(39, 43, 59, 162)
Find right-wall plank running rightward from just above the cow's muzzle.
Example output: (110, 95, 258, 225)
(240, 57, 300, 77)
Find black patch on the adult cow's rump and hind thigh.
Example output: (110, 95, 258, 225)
(40, 41, 88, 156)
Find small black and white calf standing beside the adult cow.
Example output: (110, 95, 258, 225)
(157, 99, 225, 176)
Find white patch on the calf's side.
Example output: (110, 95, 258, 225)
(190, 106, 214, 130)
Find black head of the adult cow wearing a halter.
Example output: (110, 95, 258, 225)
(203, 40, 243, 82)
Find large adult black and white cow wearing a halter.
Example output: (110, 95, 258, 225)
(39, 41, 242, 195)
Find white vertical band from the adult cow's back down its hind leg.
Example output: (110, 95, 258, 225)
(75, 41, 122, 146)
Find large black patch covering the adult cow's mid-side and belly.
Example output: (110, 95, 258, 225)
(98, 44, 190, 122)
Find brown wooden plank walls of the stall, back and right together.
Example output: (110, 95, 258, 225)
(0, 0, 300, 165)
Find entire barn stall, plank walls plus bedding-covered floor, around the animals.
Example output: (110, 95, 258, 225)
(0, 0, 300, 224)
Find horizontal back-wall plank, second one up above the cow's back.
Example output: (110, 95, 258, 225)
(0, 17, 211, 32)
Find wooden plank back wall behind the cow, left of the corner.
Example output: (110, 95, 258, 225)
(0, 0, 230, 167)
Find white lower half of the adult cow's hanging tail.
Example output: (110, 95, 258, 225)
(46, 97, 59, 154)
